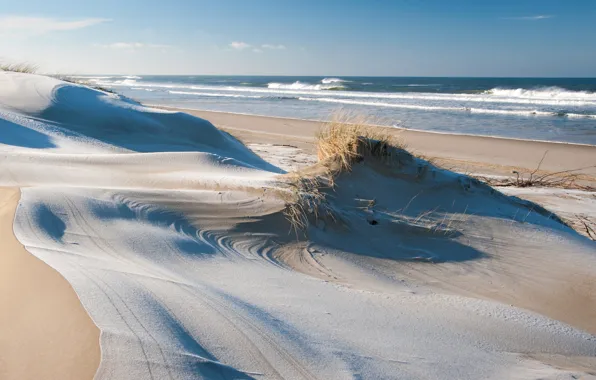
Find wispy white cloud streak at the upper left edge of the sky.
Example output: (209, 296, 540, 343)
(0, 15, 111, 35)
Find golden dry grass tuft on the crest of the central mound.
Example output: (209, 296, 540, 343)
(317, 113, 403, 172)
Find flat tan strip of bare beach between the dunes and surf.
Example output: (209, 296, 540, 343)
(166, 109, 596, 180)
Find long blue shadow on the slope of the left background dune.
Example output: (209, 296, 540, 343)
(39, 85, 283, 173)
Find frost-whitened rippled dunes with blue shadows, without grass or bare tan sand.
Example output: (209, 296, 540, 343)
(0, 73, 596, 379)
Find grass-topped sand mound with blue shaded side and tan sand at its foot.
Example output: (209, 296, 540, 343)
(272, 125, 596, 332)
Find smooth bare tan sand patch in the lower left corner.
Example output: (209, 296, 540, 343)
(0, 188, 100, 380)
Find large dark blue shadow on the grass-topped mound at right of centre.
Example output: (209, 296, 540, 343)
(230, 151, 584, 263)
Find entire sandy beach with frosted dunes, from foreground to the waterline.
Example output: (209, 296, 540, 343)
(0, 72, 596, 380)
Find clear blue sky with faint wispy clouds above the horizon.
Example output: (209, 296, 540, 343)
(0, 0, 596, 77)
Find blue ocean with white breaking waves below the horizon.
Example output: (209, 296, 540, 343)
(78, 75, 596, 145)
